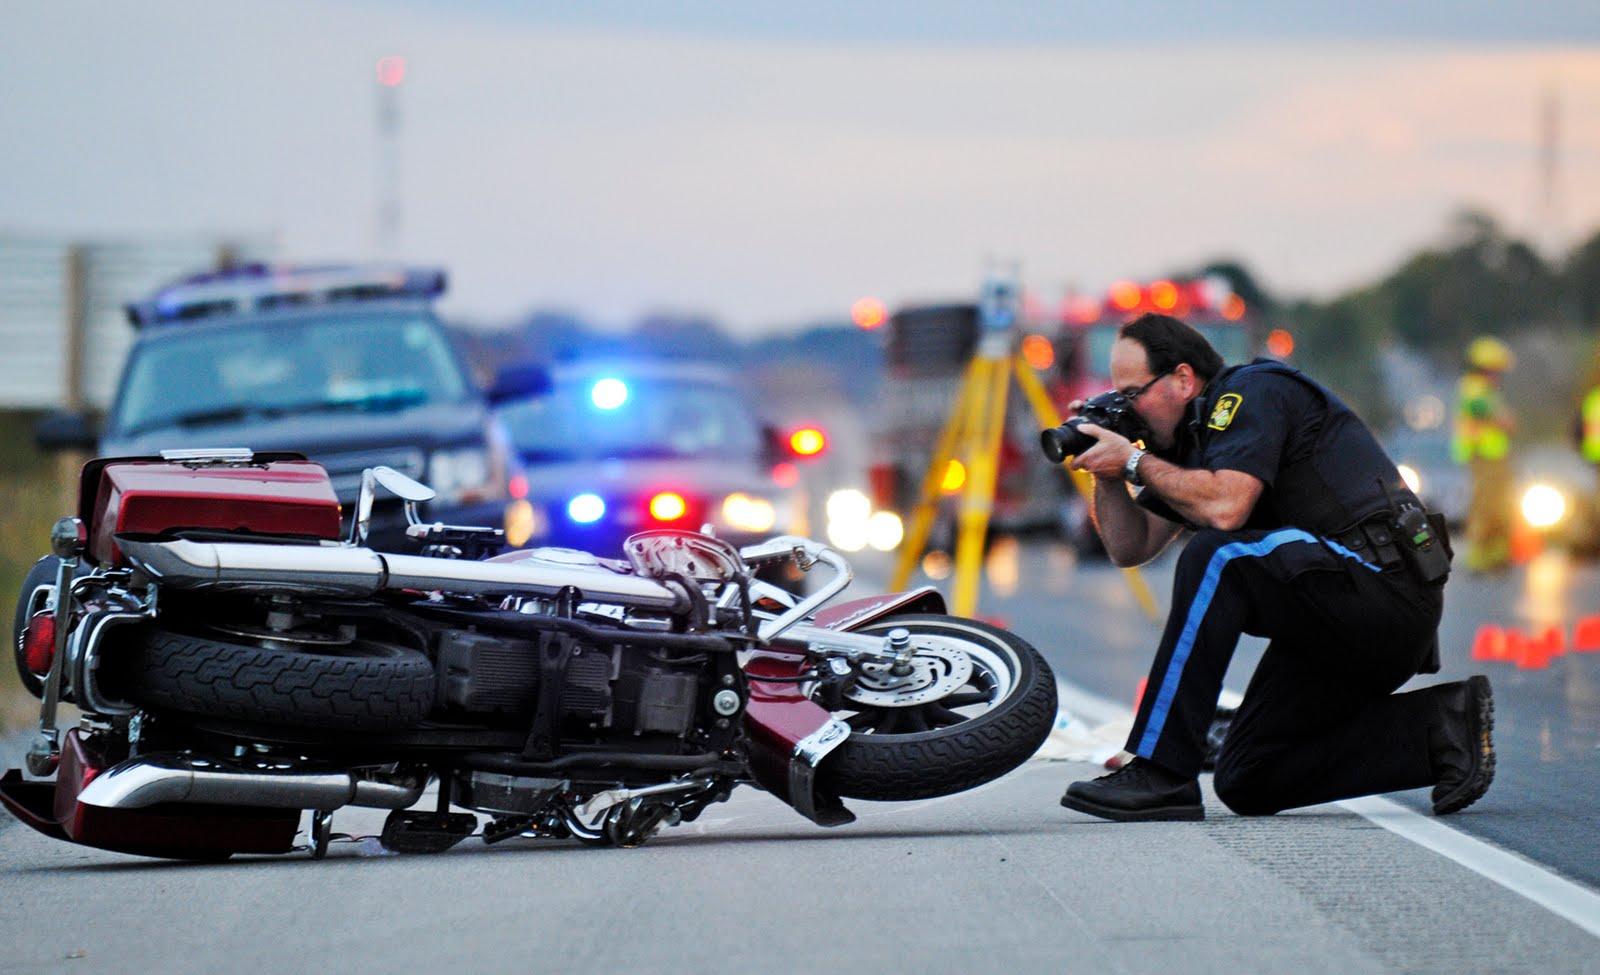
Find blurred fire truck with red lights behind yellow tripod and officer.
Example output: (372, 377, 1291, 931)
(872, 279, 1260, 554)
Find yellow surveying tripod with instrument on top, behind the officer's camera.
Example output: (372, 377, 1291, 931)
(890, 274, 1158, 620)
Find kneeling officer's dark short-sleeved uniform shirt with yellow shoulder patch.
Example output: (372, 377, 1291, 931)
(1138, 359, 1414, 536)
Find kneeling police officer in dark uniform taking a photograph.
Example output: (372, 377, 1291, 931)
(1061, 315, 1494, 820)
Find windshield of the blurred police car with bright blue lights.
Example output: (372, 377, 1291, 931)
(501, 373, 762, 461)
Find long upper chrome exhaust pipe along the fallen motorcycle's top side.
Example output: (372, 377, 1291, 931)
(117, 535, 690, 613)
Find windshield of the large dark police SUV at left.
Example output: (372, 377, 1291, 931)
(112, 314, 470, 437)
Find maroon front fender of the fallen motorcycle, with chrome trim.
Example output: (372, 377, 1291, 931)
(744, 650, 856, 826)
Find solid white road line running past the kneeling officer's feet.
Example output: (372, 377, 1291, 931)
(1056, 679, 1600, 938)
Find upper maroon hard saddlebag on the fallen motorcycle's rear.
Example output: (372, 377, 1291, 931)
(78, 455, 339, 565)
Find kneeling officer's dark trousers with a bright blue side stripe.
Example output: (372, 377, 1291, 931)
(1128, 528, 1443, 815)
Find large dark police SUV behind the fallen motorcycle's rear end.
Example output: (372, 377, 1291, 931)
(35, 264, 517, 551)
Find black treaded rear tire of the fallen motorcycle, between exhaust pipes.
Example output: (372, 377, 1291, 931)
(117, 629, 435, 732)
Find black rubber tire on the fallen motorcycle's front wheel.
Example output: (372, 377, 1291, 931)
(819, 616, 1056, 802)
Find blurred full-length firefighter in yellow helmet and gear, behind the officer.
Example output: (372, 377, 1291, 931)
(1451, 336, 1515, 572)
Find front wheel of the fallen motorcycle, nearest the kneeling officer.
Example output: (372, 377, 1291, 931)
(818, 615, 1056, 800)
